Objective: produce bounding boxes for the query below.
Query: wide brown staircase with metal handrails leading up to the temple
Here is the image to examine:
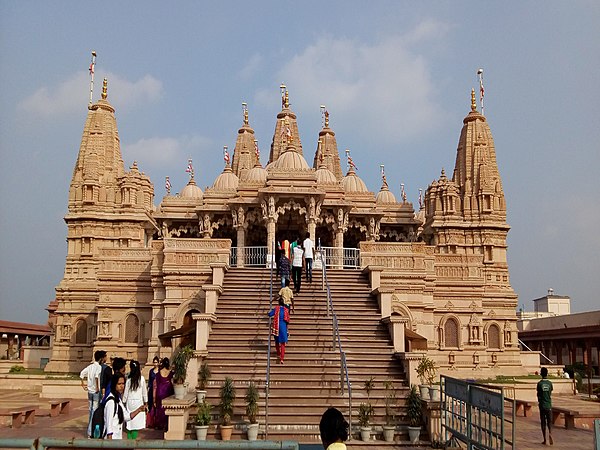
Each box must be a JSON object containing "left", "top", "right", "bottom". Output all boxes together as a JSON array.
[{"left": 199, "top": 268, "right": 407, "bottom": 446}]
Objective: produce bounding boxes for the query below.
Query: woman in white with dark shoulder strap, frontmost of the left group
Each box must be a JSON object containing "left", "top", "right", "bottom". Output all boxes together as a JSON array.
[{"left": 103, "top": 372, "right": 146, "bottom": 439}]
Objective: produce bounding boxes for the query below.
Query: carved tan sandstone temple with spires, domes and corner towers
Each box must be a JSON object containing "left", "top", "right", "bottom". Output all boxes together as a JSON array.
[{"left": 46, "top": 80, "right": 523, "bottom": 396}]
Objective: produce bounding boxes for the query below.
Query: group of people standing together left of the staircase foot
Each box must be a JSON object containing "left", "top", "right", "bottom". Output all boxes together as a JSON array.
[{"left": 80, "top": 350, "right": 173, "bottom": 439}]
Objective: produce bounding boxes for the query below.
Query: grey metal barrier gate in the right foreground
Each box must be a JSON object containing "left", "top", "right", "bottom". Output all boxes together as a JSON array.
[{"left": 441, "top": 375, "right": 516, "bottom": 450}]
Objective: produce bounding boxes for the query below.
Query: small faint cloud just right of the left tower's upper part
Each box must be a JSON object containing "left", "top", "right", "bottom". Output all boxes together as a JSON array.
[{"left": 121, "top": 136, "right": 211, "bottom": 168}]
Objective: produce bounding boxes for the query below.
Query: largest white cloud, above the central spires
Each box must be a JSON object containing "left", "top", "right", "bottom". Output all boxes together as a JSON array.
[{"left": 256, "top": 21, "right": 445, "bottom": 147}]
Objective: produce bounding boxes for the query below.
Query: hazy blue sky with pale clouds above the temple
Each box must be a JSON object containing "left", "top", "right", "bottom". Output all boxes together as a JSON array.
[{"left": 0, "top": 0, "right": 600, "bottom": 323}]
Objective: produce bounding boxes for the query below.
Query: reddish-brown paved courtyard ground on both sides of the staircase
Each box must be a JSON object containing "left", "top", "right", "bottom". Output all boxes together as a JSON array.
[{"left": 0, "top": 389, "right": 600, "bottom": 450}]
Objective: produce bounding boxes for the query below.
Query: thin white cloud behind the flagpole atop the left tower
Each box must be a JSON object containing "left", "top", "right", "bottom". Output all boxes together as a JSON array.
[{"left": 18, "top": 71, "right": 163, "bottom": 117}]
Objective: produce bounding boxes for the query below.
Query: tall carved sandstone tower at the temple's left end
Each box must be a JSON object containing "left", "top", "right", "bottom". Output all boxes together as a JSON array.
[{"left": 48, "top": 79, "right": 155, "bottom": 371}]
